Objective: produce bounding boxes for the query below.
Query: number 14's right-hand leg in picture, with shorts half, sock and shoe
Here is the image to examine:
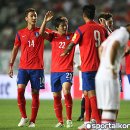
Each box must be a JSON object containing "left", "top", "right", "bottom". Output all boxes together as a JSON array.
[{"left": 29, "top": 70, "right": 44, "bottom": 127}]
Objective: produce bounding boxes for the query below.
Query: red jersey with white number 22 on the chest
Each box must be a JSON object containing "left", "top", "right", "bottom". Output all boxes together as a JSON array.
[{"left": 48, "top": 32, "right": 75, "bottom": 72}]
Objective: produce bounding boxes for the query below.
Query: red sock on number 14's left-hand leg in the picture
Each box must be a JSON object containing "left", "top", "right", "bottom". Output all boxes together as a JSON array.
[{"left": 17, "top": 88, "right": 27, "bottom": 118}]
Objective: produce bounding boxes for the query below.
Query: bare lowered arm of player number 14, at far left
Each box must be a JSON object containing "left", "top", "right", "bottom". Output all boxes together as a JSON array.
[{"left": 8, "top": 45, "right": 19, "bottom": 78}]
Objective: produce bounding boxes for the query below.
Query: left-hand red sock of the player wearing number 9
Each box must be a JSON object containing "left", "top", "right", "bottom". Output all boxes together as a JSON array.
[{"left": 85, "top": 96, "right": 91, "bottom": 121}]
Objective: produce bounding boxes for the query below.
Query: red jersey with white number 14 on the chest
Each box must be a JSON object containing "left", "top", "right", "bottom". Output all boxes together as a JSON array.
[{"left": 14, "top": 27, "right": 44, "bottom": 69}]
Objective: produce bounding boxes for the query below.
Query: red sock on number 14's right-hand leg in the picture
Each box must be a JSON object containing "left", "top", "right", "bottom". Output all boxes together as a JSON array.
[{"left": 30, "top": 94, "right": 39, "bottom": 123}]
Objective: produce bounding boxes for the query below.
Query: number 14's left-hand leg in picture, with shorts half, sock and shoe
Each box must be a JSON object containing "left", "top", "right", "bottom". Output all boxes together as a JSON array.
[{"left": 17, "top": 69, "right": 29, "bottom": 127}]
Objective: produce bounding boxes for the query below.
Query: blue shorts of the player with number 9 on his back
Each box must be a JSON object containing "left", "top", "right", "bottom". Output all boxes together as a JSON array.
[{"left": 82, "top": 71, "right": 97, "bottom": 91}]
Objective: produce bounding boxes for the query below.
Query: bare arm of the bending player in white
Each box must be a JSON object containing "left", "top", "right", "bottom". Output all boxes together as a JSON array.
[{"left": 110, "top": 41, "right": 120, "bottom": 78}]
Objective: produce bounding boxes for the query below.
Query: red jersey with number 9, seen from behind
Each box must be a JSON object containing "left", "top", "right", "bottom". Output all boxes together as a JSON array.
[{"left": 72, "top": 21, "right": 105, "bottom": 72}]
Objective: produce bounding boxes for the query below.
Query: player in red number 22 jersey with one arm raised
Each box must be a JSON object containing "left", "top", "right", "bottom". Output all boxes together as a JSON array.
[{"left": 40, "top": 11, "right": 75, "bottom": 128}]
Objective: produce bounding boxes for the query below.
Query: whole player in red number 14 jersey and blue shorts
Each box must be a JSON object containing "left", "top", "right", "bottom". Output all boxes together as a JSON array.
[{"left": 9, "top": 8, "right": 44, "bottom": 127}]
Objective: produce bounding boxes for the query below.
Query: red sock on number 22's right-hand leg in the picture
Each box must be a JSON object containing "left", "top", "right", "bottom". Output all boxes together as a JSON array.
[{"left": 64, "top": 93, "right": 73, "bottom": 120}]
